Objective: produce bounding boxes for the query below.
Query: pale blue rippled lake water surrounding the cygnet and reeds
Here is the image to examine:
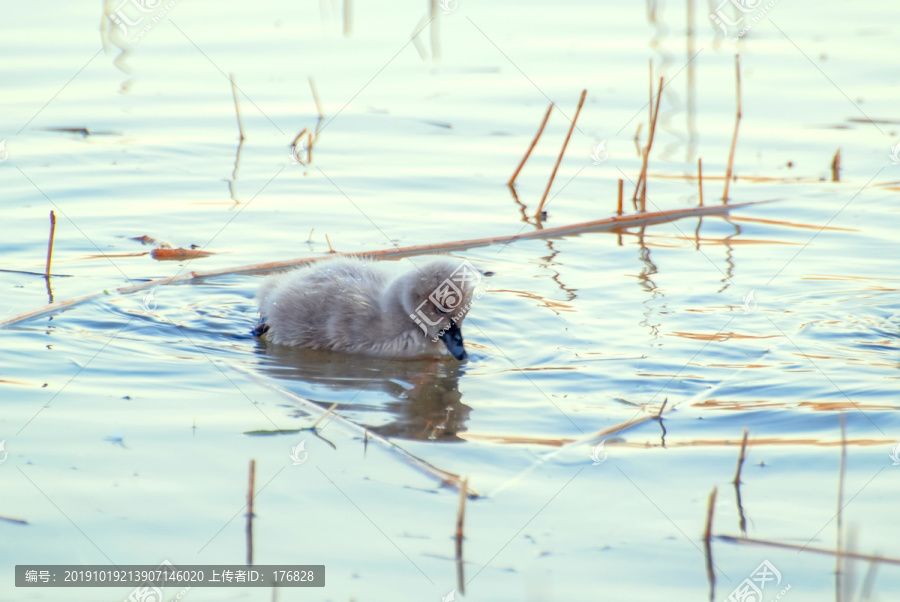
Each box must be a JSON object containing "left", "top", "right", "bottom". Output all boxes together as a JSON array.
[{"left": 0, "top": 0, "right": 900, "bottom": 602}]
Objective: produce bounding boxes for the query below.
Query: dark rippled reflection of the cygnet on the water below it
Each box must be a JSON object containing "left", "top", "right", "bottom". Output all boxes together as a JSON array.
[{"left": 250, "top": 343, "right": 472, "bottom": 441}]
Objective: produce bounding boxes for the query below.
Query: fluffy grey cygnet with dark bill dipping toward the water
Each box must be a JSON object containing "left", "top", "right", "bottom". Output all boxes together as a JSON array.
[{"left": 255, "top": 258, "right": 480, "bottom": 360}]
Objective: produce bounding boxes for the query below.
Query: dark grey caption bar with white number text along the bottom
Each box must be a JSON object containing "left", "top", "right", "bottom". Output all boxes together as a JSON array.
[{"left": 16, "top": 562, "right": 325, "bottom": 589}]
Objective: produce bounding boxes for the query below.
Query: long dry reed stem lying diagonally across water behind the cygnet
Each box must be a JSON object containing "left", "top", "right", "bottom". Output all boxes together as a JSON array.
[{"left": 0, "top": 200, "right": 772, "bottom": 326}]
